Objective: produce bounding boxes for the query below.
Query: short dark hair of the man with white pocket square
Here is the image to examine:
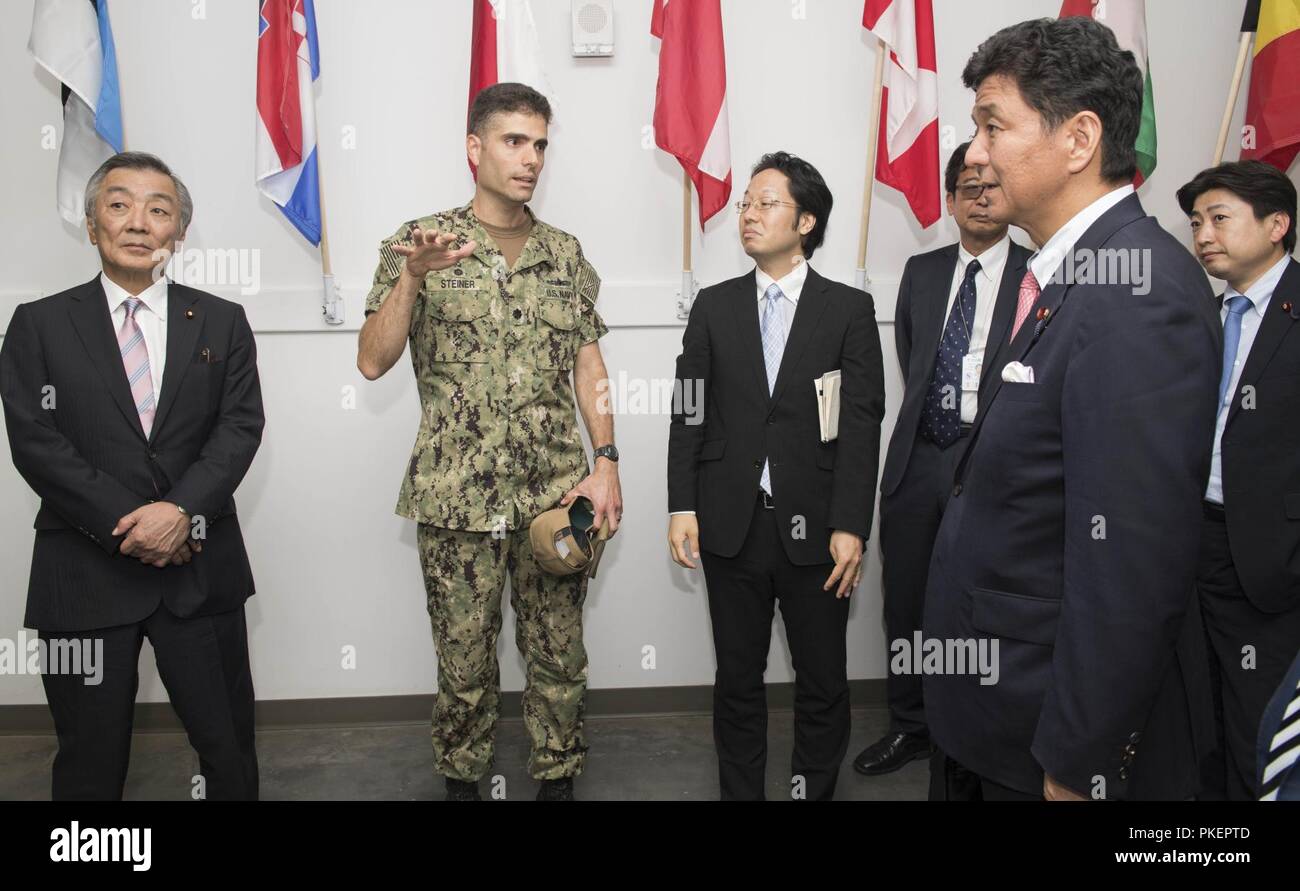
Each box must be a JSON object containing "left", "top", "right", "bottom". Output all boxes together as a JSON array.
[{"left": 962, "top": 16, "right": 1145, "bottom": 182}]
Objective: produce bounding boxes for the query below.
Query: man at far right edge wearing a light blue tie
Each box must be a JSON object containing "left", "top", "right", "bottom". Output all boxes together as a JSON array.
[{"left": 1178, "top": 161, "right": 1300, "bottom": 801}]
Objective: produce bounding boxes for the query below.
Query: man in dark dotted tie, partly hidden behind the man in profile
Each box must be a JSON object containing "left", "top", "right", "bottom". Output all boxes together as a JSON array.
[{"left": 853, "top": 142, "right": 1030, "bottom": 777}]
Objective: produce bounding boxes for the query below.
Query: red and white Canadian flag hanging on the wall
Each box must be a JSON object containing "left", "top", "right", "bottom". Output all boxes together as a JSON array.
[{"left": 862, "top": 0, "right": 940, "bottom": 229}]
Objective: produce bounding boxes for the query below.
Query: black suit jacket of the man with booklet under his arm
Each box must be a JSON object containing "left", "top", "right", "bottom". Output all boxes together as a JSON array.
[{"left": 668, "top": 267, "right": 885, "bottom": 566}]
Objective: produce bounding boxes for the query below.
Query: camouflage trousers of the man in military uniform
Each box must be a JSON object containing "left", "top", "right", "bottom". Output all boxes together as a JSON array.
[{"left": 416, "top": 523, "right": 588, "bottom": 780}]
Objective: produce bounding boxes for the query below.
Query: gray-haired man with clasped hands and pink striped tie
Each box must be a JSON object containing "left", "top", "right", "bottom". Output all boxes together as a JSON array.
[{"left": 0, "top": 152, "right": 263, "bottom": 800}]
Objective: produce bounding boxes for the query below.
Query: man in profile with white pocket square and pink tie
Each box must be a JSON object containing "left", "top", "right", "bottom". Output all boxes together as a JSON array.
[{"left": 923, "top": 18, "right": 1222, "bottom": 800}]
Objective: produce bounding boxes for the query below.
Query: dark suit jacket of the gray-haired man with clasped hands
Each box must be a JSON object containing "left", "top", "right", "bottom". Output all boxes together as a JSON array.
[{"left": 0, "top": 276, "right": 263, "bottom": 631}]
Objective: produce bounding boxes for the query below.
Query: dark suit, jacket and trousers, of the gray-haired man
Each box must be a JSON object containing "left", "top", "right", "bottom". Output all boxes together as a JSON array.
[{"left": 0, "top": 276, "right": 263, "bottom": 799}]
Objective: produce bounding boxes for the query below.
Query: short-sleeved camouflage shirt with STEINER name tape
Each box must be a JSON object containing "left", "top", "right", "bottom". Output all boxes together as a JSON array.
[{"left": 365, "top": 204, "right": 608, "bottom": 532}]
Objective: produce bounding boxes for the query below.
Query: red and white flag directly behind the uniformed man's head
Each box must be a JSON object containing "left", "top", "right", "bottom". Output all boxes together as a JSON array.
[{"left": 465, "top": 0, "right": 555, "bottom": 170}]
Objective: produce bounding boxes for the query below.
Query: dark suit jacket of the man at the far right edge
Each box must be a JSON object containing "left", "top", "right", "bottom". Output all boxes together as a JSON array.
[{"left": 1219, "top": 259, "right": 1300, "bottom": 613}]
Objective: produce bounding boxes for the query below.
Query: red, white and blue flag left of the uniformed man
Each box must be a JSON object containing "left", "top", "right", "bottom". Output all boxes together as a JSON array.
[{"left": 256, "top": 0, "right": 321, "bottom": 245}]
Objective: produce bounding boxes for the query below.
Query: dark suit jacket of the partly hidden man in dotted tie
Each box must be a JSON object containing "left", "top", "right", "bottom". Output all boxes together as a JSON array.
[{"left": 880, "top": 241, "right": 1031, "bottom": 497}]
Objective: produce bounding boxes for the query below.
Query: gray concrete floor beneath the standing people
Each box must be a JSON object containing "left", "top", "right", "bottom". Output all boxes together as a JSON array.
[{"left": 0, "top": 708, "right": 930, "bottom": 801}]
